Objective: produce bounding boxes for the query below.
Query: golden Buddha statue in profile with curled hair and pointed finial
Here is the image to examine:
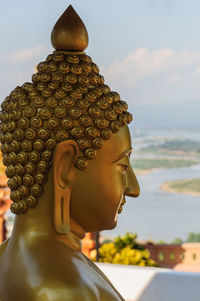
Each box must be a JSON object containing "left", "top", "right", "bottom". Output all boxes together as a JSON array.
[{"left": 0, "top": 6, "right": 139, "bottom": 301}]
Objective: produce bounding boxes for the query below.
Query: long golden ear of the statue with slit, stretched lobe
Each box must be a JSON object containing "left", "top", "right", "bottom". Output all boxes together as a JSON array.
[{"left": 53, "top": 140, "right": 78, "bottom": 233}]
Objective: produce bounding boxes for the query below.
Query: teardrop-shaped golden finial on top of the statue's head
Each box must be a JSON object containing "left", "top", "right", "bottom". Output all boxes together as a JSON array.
[{"left": 51, "top": 5, "right": 88, "bottom": 51}]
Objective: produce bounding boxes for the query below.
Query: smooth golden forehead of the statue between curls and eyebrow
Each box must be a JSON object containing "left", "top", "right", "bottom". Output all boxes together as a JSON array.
[{"left": 97, "top": 125, "right": 131, "bottom": 162}]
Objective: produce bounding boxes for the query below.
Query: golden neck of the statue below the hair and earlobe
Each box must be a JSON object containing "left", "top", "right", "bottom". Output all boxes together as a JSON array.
[{"left": 11, "top": 171, "right": 85, "bottom": 250}]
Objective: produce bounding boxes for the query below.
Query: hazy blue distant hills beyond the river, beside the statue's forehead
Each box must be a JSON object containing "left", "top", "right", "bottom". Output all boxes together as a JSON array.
[{"left": 131, "top": 100, "right": 200, "bottom": 129}]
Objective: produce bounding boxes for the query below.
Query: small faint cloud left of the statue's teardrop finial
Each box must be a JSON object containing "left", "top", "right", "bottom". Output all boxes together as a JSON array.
[{"left": 9, "top": 46, "right": 46, "bottom": 63}]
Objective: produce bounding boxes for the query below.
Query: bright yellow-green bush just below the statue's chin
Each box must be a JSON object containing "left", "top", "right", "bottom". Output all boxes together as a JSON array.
[{"left": 99, "top": 232, "right": 158, "bottom": 266}]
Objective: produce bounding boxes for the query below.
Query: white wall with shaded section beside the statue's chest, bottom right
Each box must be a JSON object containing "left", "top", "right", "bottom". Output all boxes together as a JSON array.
[{"left": 97, "top": 263, "right": 200, "bottom": 301}]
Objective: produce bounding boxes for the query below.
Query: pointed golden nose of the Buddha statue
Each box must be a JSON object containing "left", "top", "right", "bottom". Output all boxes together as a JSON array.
[{"left": 124, "top": 166, "right": 140, "bottom": 198}]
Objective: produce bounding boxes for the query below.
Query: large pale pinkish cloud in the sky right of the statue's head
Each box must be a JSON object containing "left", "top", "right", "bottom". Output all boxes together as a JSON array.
[{"left": 104, "top": 48, "right": 200, "bottom": 87}]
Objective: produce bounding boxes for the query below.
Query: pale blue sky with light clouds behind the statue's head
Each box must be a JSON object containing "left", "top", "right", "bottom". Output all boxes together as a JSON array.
[{"left": 0, "top": 0, "right": 200, "bottom": 109}]
